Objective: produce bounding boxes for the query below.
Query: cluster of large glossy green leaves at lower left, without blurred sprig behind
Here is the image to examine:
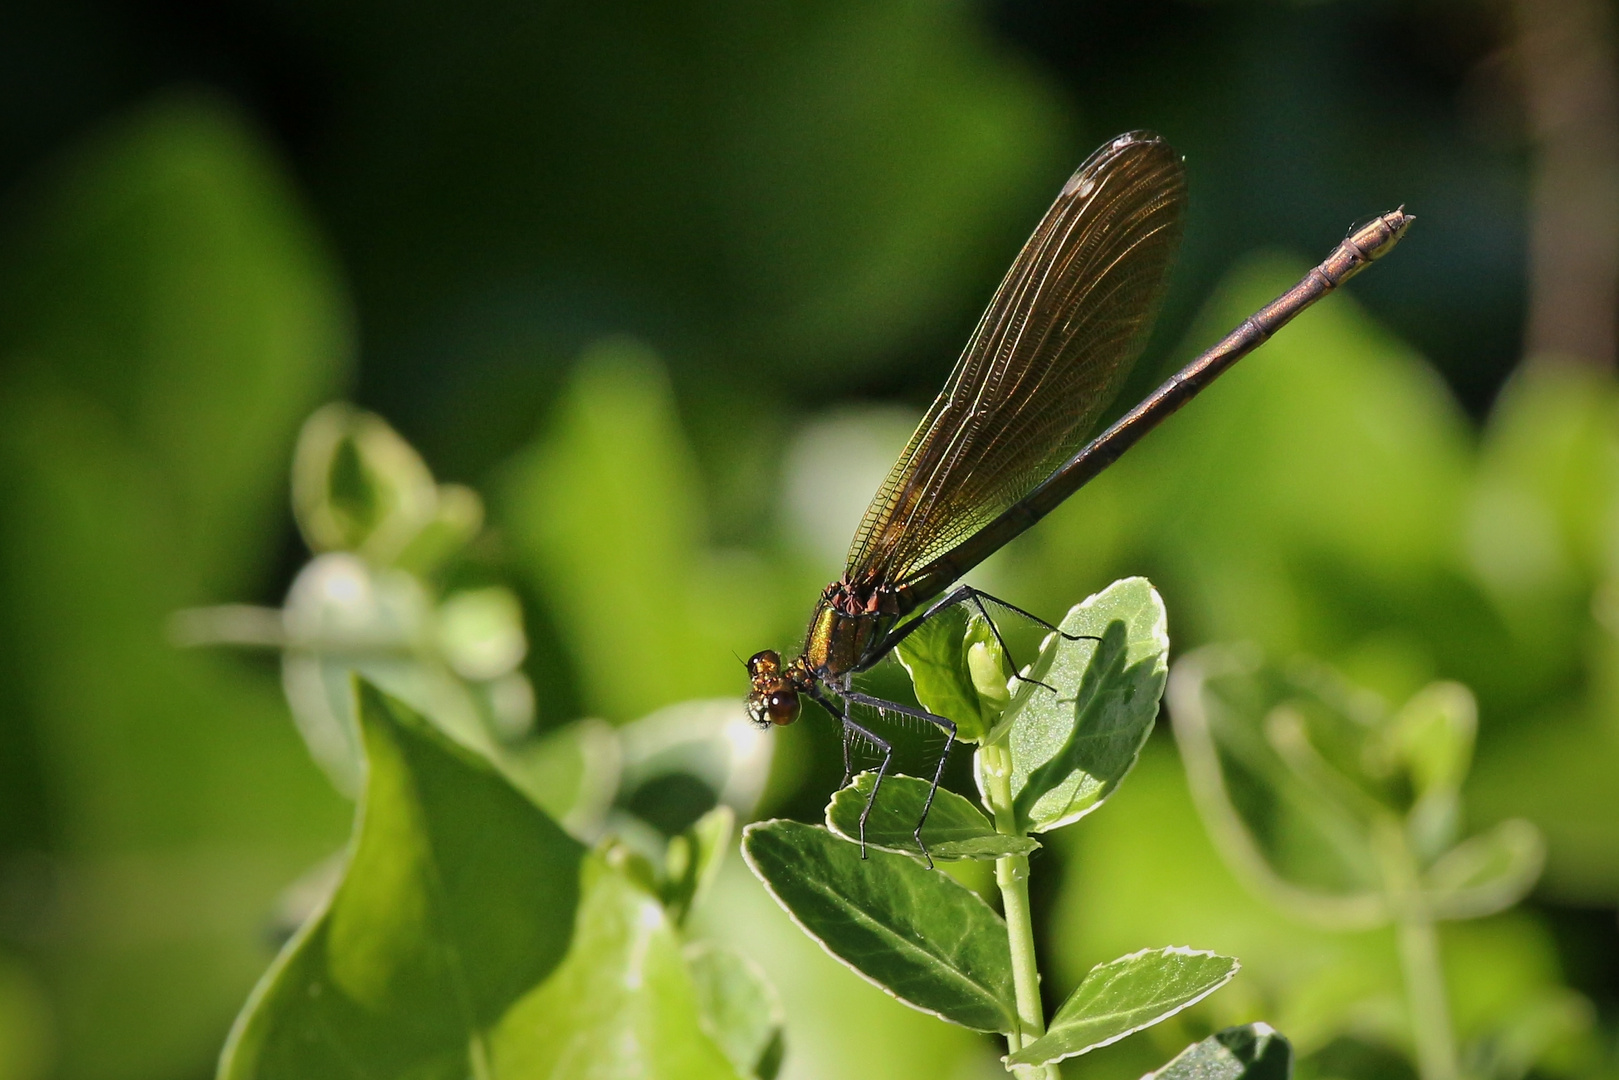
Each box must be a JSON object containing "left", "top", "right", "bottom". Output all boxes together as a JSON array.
[{"left": 220, "top": 682, "right": 782, "bottom": 1080}]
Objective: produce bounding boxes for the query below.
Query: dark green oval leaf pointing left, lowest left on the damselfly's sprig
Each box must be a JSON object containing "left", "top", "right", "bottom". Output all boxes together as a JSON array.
[{"left": 742, "top": 821, "right": 1015, "bottom": 1031}]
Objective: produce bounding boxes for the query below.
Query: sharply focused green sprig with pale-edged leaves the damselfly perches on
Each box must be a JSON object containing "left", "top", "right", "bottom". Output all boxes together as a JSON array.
[{"left": 743, "top": 578, "right": 1275, "bottom": 1077}]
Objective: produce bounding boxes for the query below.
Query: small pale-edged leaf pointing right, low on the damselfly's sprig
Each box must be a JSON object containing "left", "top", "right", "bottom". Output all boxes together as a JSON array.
[{"left": 1007, "top": 949, "right": 1242, "bottom": 1065}]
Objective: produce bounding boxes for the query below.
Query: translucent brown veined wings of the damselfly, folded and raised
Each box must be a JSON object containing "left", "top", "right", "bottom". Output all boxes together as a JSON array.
[{"left": 845, "top": 131, "right": 1187, "bottom": 595}]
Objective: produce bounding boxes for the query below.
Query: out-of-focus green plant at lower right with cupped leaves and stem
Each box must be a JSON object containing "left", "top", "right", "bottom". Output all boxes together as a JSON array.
[{"left": 1169, "top": 646, "right": 1590, "bottom": 1080}]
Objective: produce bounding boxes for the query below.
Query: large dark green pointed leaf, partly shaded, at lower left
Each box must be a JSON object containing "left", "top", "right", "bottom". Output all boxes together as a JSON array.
[{"left": 219, "top": 683, "right": 586, "bottom": 1080}]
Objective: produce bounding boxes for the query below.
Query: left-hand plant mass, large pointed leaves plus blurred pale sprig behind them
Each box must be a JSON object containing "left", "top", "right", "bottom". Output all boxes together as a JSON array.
[{"left": 199, "top": 405, "right": 799, "bottom": 1080}]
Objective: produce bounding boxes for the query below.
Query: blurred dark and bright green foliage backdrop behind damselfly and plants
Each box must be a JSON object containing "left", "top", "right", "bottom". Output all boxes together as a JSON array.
[{"left": 0, "top": 0, "right": 1619, "bottom": 1080}]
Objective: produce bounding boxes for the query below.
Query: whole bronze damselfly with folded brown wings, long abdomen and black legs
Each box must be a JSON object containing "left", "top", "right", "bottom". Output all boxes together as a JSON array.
[{"left": 748, "top": 131, "right": 1412, "bottom": 853}]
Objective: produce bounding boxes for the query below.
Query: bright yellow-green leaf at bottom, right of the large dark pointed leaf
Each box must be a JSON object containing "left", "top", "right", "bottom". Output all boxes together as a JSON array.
[{"left": 492, "top": 858, "right": 740, "bottom": 1080}]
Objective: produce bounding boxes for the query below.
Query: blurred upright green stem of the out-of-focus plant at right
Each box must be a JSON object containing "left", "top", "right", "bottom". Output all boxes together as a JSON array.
[{"left": 1378, "top": 818, "right": 1459, "bottom": 1080}]
